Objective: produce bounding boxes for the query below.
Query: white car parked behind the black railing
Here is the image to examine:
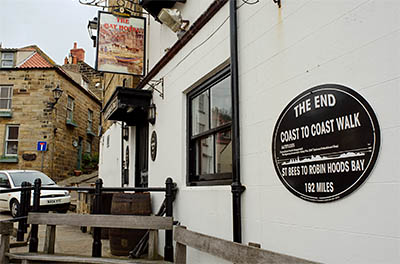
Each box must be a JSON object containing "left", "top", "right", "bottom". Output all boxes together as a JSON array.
[{"left": 0, "top": 170, "right": 71, "bottom": 217}]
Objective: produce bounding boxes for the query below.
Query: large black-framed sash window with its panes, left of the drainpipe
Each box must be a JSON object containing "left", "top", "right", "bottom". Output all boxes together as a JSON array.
[{"left": 188, "top": 68, "right": 232, "bottom": 185}]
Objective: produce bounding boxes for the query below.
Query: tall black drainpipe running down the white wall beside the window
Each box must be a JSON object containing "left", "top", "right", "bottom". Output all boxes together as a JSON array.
[{"left": 229, "top": 0, "right": 246, "bottom": 243}]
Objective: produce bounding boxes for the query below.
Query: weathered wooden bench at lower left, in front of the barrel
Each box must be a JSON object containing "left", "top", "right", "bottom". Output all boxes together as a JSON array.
[{"left": 0, "top": 213, "right": 173, "bottom": 264}]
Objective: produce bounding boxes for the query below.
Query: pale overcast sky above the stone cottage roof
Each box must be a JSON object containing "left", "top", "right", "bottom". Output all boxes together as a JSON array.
[{"left": 0, "top": 0, "right": 100, "bottom": 67}]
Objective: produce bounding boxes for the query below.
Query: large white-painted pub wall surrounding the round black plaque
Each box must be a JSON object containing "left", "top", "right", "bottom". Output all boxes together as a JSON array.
[{"left": 138, "top": 0, "right": 400, "bottom": 263}]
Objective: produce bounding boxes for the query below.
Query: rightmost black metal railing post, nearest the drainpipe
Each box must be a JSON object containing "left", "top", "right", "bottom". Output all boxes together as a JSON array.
[{"left": 164, "top": 178, "right": 174, "bottom": 262}]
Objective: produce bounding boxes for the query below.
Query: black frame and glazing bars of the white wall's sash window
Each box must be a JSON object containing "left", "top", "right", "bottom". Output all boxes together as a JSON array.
[{"left": 186, "top": 66, "right": 234, "bottom": 186}]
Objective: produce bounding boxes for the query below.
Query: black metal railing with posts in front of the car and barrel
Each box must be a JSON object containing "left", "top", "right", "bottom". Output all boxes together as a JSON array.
[{"left": 0, "top": 178, "right": 177, "bottom": 261}]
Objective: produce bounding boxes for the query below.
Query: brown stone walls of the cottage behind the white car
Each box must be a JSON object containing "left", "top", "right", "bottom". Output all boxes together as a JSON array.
[{"left": 0, "top": 68, "right": 101, "bottom": 181}]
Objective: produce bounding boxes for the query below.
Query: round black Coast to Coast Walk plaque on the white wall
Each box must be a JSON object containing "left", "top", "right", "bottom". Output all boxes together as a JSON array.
[{"left": 272, "top": 84, "right": 380, "bottom": 202}]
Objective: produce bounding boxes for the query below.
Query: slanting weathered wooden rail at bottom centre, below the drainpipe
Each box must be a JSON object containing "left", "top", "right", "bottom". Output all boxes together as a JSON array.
[{"left": 174, "top": 226, "right": 316, "bottom": 264}]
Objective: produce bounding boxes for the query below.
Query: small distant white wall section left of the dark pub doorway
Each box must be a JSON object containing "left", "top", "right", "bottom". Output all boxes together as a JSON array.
[{"left": 99, "top": 122, "right": 121, "bottom": 187}]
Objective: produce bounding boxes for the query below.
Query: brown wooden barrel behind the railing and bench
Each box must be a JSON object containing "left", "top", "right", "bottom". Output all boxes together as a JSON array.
[{"left": 109, "top": 193, "right": 151, "bottom": 256}]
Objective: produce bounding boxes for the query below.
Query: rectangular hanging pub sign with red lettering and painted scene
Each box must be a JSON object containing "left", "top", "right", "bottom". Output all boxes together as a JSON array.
[{"left": 96, "top": 11, "right": 146, "bottom": 76}]
